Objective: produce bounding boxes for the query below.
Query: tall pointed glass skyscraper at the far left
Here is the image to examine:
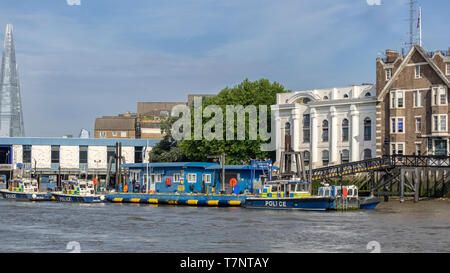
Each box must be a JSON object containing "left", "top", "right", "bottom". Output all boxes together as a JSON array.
[{"left": 0, "top": 24, "right": 25, "bottom": 137}]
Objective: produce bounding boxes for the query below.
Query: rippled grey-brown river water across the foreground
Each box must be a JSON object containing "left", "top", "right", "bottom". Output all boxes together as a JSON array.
[{"left": 0, "top": 199, "right": 450, "bottom": 253}]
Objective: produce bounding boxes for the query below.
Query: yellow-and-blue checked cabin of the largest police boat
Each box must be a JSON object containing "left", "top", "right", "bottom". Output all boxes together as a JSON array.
[{"left": 262, "top": 180, "right": 311, "bottom": 198}]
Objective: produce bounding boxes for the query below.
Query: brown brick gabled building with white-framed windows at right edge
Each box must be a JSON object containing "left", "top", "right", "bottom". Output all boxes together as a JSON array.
[{"left": 376, "top": 45, "right": 450, "bottom": 156}]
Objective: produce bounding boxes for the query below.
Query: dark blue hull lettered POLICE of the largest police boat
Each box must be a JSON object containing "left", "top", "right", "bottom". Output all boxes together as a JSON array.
[{"left": 244, "top": 197, "right": 333, "bottom": 211}]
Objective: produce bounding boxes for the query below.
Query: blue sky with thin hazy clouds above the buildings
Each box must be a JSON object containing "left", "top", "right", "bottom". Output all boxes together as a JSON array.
[{"left": 0, "top": 0, "right": 450, "bottom": 137}]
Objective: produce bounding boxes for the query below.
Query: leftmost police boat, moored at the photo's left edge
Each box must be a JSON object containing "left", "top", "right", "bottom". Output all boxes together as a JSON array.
[{"left": 0, "top": 178, "right": 52, "bottom": 201}]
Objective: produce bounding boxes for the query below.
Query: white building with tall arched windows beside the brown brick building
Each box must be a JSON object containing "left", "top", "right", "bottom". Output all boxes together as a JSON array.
[{"left": 271, "top": 84, "right": 376, "bottom": 168}]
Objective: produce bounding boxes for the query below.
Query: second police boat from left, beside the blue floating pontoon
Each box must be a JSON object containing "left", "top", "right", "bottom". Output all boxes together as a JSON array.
[{"left": 52, "top": 180, "right": 106, "bottom": 203}]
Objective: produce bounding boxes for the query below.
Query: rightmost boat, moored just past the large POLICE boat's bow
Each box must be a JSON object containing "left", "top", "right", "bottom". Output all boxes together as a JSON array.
[{"left": 318, "top": 184, "right": 380, "bottom": 210}]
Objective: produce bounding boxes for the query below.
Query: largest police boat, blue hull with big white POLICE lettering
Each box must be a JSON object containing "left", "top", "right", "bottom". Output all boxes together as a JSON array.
[{"left": 244, "top": 179, "right": 333, "bottom": 211}]
